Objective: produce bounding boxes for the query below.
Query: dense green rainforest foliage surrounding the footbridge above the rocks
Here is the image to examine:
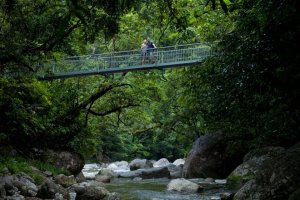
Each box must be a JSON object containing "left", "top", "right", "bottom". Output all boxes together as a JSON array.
[{"left": 0, "top": 0, "right": 300, "bottom": 160}]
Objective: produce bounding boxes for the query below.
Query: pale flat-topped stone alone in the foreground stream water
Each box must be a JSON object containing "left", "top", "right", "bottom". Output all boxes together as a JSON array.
[{"left": 167, "top": 178, "right": 202, "bottom": 194}]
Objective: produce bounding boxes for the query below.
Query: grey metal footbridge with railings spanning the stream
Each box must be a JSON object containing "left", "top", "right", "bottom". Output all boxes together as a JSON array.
[{"left": 37, "top": 43, "right": 211, "bottom": 80}]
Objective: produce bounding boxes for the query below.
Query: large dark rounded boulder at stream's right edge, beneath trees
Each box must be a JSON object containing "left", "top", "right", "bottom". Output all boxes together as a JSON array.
[{"left": 183, "top": 132, "right": 243, "bottom": 178}]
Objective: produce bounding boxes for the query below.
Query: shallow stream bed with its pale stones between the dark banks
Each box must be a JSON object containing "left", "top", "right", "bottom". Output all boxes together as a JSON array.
[{"left": 83, "top": 159, "right": 232, "bottom": 200}]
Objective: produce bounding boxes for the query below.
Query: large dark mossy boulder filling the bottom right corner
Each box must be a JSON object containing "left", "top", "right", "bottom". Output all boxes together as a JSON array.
[{"left": 231, "top": 143, "right": 300, "bottom": 200}]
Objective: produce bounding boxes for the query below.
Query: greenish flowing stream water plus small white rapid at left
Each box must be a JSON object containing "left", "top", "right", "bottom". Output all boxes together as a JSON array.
[{"left": 84, "top": 164, "right": 231, "bottom": 200}]
